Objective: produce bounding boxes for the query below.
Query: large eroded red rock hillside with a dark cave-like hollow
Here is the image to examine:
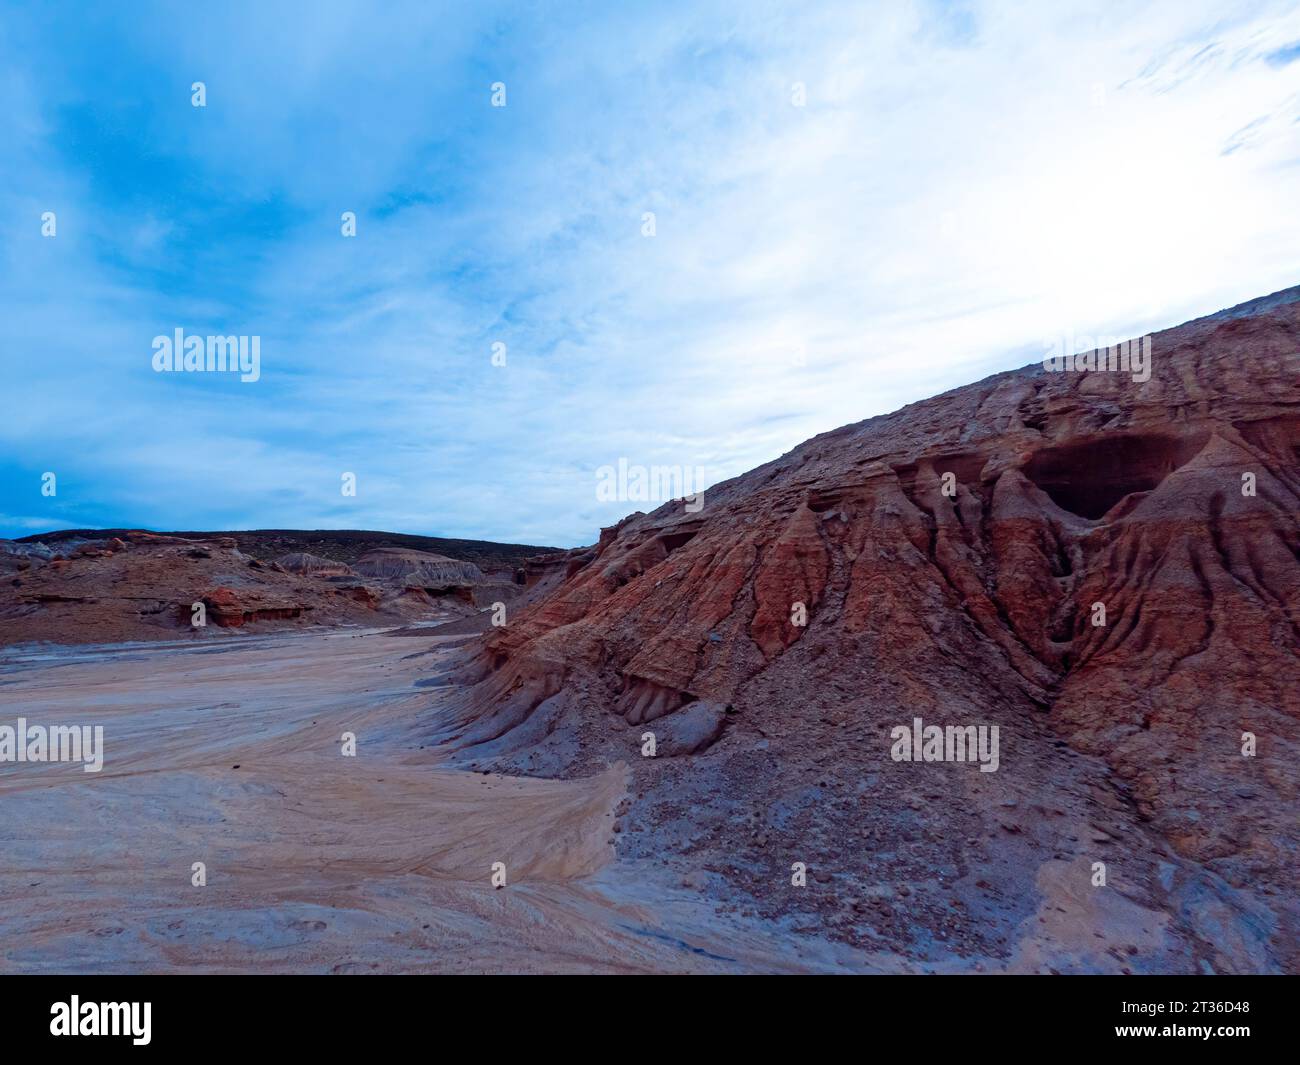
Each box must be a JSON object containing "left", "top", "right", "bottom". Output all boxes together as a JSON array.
[{"left": 445, "top": 289, "right": 1300, "bottom": 969}]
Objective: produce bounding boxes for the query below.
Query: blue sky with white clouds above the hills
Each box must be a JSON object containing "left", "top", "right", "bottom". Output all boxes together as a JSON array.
[{"left": 0, "top": 0, "right": 1300, "bottom": 546}]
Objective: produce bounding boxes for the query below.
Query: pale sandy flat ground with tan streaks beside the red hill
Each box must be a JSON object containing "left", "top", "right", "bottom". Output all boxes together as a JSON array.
[{"left": 0, "top": 631, "right": 878, "bottom": 973}]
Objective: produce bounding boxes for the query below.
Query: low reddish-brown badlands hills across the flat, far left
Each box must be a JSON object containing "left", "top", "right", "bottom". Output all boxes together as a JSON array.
[{"left": 0, "top": 529, "right": 559, "bottom": 645}]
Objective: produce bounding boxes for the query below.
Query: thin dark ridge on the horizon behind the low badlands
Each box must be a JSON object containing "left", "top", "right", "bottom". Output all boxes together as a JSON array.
[{"left": 20, "top": 529, "right": 560, "bottom": 573}]
